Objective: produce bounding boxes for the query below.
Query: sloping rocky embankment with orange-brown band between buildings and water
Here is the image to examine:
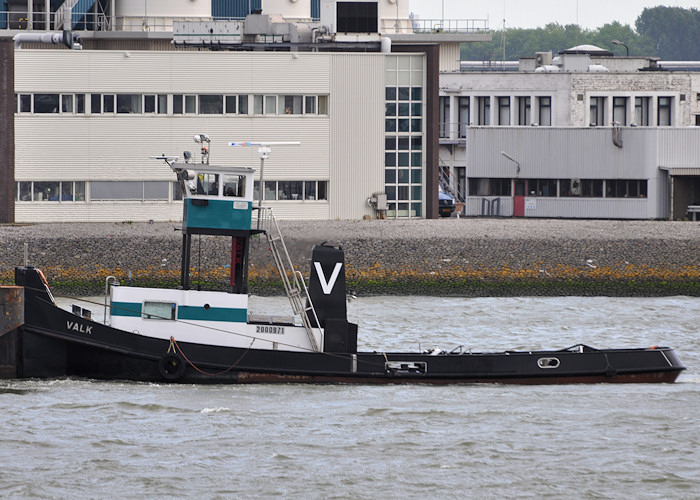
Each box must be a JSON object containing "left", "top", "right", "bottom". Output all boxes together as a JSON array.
[{"left": 0, "top": 218, "right": 700, "bottom": 296}]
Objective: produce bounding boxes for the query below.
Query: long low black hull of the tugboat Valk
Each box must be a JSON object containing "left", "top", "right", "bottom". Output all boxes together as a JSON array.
[{"left": 0, "top": 297, "right": 684, "bottom": 384}]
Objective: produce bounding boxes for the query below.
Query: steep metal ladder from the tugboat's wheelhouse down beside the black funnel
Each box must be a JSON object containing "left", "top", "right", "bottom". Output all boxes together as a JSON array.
[{"left": 254, "top": 207, "right": 321, "bottom": 352}]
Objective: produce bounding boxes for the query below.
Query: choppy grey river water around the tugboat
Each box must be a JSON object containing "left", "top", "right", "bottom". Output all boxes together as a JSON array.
[{"left": 0, "top": 297, "right": 700, "bottom": 499}]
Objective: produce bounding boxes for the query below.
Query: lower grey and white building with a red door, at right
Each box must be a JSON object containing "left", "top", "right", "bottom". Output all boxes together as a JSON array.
[{"left": 439, "top": 46, "right": 700, "bottom": 219}]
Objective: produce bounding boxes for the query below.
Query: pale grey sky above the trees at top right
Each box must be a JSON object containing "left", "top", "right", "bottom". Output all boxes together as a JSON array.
[{"left": 408, "top": 0, "right": 700, "bottom": 29}]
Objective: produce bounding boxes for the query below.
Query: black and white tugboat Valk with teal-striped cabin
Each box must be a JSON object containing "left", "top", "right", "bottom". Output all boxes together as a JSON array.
[{"left": 0, "top": 140, "right": 685, "bottom": 384}]
